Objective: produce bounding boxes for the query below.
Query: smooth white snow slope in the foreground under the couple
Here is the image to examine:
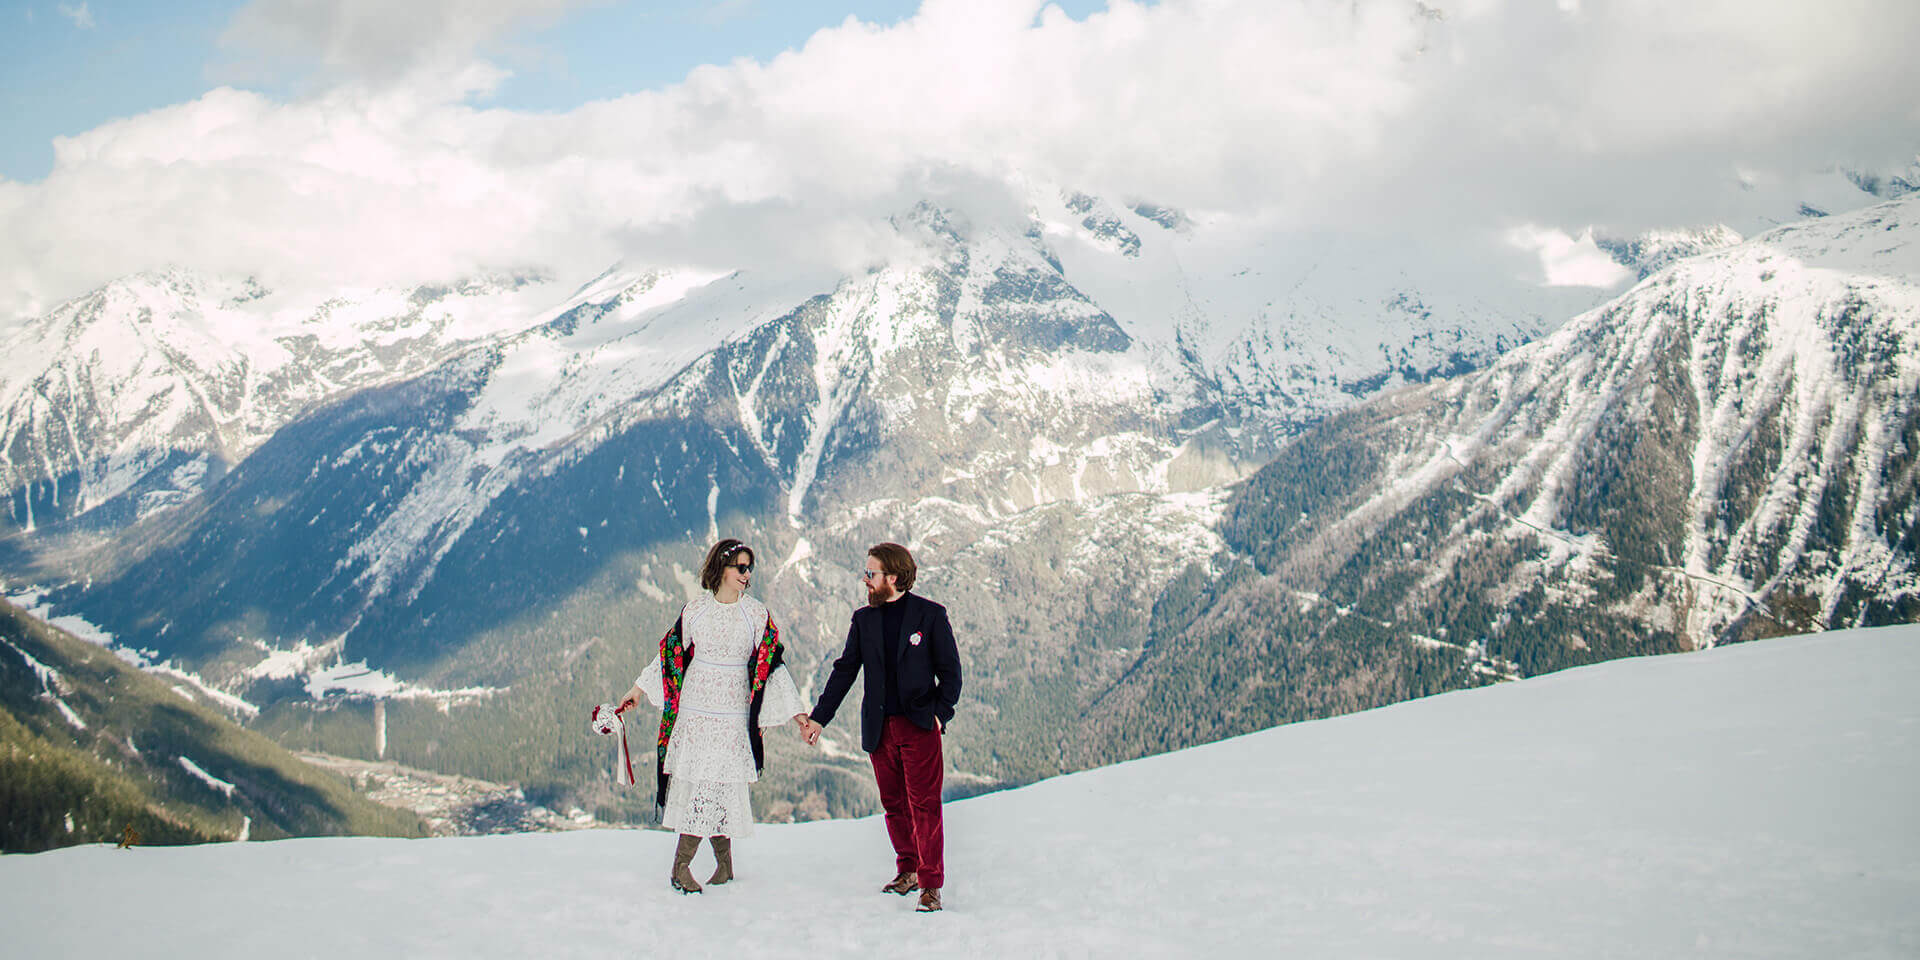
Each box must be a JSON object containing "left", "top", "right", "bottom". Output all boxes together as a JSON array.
[{"left": 0, "top": 626, "right": 1920, "bottom": 958}]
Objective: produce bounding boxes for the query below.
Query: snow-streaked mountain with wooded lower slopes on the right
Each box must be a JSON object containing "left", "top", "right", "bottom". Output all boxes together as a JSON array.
[{"left": 1064, "top": 196, "right": 1920, "bottom": 756}]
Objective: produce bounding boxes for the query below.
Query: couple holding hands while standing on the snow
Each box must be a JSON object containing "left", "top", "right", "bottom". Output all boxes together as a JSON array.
[{"left": 620, "top": 540, "right": 960, "bottom": 912}]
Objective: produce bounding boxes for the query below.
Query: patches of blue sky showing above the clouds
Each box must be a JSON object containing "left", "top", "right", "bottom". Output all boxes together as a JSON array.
[{"left": 0, "top": 0, "right": 1106, "bottom": 182}]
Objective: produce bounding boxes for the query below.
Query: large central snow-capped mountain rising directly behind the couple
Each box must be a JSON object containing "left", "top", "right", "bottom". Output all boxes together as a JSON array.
[{"left": 15, "top": 167, "right": 1910, "bottom": 812}]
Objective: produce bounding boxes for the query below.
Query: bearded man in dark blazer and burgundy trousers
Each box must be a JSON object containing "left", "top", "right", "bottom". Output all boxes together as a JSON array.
[{"left": 806, "top": 543, "right": 960, "bottom": 912}]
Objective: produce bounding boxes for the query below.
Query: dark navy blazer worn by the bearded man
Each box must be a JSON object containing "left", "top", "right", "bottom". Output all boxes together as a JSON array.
[{"left": 812, "top": 593, "right": 960, "bottom": 753}]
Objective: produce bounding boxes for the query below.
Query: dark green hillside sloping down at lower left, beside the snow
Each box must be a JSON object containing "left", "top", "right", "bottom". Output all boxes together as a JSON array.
[{"left": 0, "top": 603, "right": 424, "bottom": 852}]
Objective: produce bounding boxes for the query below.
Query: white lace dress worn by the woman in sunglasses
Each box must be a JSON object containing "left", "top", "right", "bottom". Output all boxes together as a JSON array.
[{"left": 636, "top": 593, "right": 806, "bottom": 837}]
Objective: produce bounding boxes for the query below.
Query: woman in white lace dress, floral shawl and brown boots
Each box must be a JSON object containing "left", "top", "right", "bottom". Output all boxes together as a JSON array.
[{"left": 620, "top": 538, "right": 806, "bottom": 893}]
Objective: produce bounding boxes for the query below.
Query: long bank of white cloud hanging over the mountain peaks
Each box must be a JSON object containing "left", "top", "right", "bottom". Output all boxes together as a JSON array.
[{"left": 0, "top": 0, "right": 1920, "bottom": 317}]
